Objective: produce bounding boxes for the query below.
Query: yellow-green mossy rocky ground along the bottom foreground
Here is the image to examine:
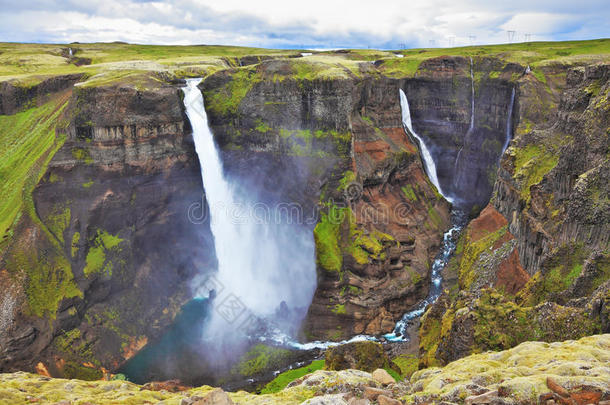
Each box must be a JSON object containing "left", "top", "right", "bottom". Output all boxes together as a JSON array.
[{"left": 0, "top": 334, "right": 610, "bottom": 405}]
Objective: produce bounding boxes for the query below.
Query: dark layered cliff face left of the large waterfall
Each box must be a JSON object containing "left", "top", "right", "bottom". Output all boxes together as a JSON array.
[{"left": 0, "top": 82, "right": 215, "bottom": 377}]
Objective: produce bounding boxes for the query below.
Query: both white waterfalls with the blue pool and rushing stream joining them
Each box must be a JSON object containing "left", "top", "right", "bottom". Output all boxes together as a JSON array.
[{"left": 123, "top": 79, "right": 480, "bottom": 387}]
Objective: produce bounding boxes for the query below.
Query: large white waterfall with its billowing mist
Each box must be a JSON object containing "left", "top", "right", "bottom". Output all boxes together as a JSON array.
[{"left": 183, "top": 79, "right": 316, "bottom": 336}]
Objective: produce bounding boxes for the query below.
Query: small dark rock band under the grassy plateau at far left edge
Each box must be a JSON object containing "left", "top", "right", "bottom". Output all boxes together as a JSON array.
[{"left": 0, "top": 73, "right": 84, "bottom": 115}]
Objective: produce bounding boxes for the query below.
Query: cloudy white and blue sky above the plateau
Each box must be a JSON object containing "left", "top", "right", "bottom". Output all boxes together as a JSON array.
[{"left": 0, "top": 0, "right": 610, "bottom": 48}]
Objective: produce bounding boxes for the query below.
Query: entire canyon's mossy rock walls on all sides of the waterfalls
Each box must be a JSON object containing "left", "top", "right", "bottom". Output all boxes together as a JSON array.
[{"left": 0, "top": 40, "right": 610, "bottom": 394}]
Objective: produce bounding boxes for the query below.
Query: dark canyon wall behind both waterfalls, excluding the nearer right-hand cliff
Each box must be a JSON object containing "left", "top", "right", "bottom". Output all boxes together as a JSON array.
[{"left": 0, "top": 57, "right": 523, "bottom": 377}]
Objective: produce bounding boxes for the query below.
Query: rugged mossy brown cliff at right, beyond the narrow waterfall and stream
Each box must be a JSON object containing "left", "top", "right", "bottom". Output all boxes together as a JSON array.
[{"left": 420, "top": 64, "right": 610, "bottom": 365}]
